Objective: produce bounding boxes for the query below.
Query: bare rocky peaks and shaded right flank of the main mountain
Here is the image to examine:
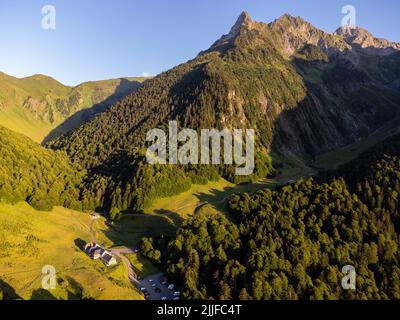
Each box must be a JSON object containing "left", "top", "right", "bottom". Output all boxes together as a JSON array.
[{"left": 212, "top": 15, "right": 400, "bottom": 157}]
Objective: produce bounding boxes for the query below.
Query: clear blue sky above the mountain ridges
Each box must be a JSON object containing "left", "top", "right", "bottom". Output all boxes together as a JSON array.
[{"left": 0, "top": 0, "right": 400, "bottom": 85}]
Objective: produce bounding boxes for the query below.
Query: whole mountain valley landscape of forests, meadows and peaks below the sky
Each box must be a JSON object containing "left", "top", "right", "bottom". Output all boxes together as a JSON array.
[{"left": 0, "top": 12, "right": 400, "bottom": 300}]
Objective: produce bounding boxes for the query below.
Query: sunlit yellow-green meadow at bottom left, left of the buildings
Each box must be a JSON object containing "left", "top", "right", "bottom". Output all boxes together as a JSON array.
[{"left": 0, "top": 203, "right": 142, "bottom": 299}]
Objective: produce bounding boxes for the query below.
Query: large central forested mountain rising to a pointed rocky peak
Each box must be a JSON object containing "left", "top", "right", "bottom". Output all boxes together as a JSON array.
[{"left": 42, "top": 13, "right": 400, "bottom": 211}]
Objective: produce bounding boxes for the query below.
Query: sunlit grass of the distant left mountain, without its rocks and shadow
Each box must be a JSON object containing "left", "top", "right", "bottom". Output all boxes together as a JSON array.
[{"left": 0, "top": 73, "right": 146, "bottom": 143}]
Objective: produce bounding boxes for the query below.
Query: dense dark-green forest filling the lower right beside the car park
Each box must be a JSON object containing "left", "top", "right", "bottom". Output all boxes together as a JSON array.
[{"left": 142, "top": 136, "right": 400, "bottom": 300}]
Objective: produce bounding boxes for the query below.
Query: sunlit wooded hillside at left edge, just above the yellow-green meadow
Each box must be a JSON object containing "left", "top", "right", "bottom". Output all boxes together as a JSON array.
[{"left": 0, "top": 126, "right": 84, "bottom": 210}]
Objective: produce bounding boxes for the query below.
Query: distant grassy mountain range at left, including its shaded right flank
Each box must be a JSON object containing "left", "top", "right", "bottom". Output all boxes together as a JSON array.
[{"left": 0, "top": 73, "right": 145, "bottom": 142}]
